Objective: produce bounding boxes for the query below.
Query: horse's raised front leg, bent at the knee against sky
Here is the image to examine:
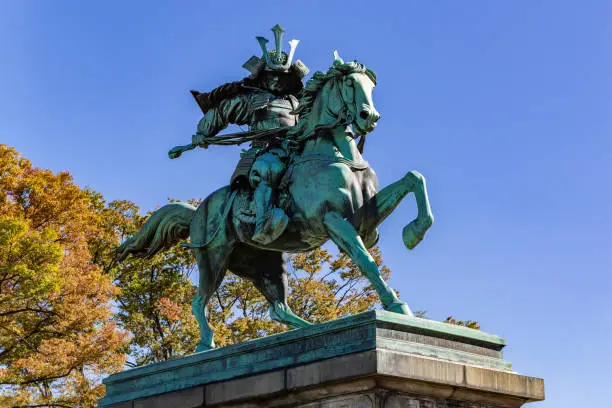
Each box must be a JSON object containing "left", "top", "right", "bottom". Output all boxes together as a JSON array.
[{"left": 355, "top": 170, "right": 434, "bottom": 249}]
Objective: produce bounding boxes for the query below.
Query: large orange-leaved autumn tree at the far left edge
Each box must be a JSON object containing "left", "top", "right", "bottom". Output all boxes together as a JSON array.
[{"left": 0, "top": 145, "right": 128, "bottom": 407}]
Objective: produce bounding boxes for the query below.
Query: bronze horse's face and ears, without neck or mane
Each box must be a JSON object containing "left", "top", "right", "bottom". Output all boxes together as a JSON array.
[{"left": 328, "top": 52, "right": 380, "bottom": 134}]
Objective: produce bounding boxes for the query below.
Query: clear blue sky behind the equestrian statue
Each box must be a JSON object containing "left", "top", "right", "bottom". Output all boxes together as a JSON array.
[{"left": 0, "top": 0, "right": 612, "bottom": 408}]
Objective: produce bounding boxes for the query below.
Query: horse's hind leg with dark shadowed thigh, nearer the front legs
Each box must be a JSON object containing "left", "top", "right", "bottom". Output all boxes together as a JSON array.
[{"left": 229, "top": 247, "right": 312, "bottom": 329}]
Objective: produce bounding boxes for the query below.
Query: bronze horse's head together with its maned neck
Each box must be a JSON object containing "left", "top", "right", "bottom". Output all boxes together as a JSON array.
[{"left": 290, "top": 52, "right": 380, "bottom": 139}]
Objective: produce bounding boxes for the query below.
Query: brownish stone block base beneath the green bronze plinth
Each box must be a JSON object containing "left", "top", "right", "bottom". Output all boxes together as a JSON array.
[{"left": 107, "top": 351, "right": 544, "bottom": 408}]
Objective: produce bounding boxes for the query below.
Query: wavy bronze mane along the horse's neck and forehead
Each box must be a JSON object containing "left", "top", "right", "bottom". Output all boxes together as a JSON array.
[{"left": 288, "top": 61, "right": 376, "bottom": 136}]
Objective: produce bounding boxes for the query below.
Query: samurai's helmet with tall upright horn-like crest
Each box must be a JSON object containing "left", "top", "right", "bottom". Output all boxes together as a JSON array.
[{"left": 242, "top": 24, "right": 310, "bottom": 79}]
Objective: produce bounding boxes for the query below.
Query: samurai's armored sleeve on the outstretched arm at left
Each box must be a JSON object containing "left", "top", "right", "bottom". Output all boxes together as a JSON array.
[{"left": 198, "top": 95, "right": 250, "bottom": 137}]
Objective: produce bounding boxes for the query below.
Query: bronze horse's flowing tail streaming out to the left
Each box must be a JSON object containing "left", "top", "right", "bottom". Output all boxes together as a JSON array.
[{"left": 115, "top": 203, "right": 196, "bottom": 261}]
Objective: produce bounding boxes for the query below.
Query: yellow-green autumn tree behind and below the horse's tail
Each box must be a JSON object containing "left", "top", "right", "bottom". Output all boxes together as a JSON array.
[{"left": 91, "top": 198, "right": 199, "bottom": 366}]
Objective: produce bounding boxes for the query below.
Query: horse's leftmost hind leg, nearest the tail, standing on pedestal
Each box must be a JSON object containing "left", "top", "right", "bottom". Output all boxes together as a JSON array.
[{"left": 191, "top": 245, "right": 231, "bottom": 353}]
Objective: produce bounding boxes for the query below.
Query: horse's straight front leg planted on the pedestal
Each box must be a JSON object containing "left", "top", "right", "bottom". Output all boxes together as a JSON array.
[{"left": 324, "top": 212, "right": 412, "bottom": 315}]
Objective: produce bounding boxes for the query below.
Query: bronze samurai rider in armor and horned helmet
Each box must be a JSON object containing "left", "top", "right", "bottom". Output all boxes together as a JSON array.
[{"left": 191, "top": 24, "right": 309, "bottom": 244}]
